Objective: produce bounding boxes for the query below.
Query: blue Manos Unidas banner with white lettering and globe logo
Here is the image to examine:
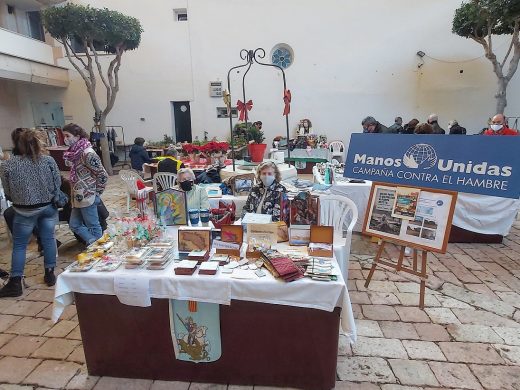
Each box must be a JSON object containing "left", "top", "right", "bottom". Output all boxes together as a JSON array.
[{"left": 343, "top": 134, "right": 520, "bottom": 199}]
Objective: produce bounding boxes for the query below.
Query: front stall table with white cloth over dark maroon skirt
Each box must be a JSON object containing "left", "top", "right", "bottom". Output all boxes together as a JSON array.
[{"left": 53, "top": 242, "right": 356, "bottom": 389}]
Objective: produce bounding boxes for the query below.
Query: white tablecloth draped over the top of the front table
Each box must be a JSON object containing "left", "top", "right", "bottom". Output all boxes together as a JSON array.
[{"left": 52, "top": 244, "right": 356, "bottom": 342}]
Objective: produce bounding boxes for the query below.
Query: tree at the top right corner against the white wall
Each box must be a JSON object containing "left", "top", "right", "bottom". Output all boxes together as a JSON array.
[{"left": 452, "top": 0, "right": 520, "bottom": 114}]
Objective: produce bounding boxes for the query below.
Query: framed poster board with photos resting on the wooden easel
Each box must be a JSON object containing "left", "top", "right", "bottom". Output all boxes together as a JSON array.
[{"left": 363, "top": 182, "right": 457, "bottom": 253}]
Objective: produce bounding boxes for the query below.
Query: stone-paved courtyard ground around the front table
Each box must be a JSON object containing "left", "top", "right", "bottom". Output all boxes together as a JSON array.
[{"left": 0, "top": 178, "right": 520, "bottom": 390}]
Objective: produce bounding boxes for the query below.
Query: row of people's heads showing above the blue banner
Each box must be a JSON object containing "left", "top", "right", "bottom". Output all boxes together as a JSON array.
[{"left": 361, "top": 114, "right": 519, "bottom": 135}]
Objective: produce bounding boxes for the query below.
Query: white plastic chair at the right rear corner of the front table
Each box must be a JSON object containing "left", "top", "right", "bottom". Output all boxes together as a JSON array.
[{"left": 320, "top": 195, "right": 358, "bottom": 283}]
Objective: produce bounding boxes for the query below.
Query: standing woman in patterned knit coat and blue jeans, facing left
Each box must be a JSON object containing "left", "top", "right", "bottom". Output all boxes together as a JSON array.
[{"left": 63, "top": 123, "right": 108, "bottom": 246}]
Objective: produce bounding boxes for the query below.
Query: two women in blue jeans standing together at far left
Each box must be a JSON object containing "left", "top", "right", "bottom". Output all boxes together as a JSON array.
[{"left": 0, "top": 124, "right": 108, "bottom": 298}]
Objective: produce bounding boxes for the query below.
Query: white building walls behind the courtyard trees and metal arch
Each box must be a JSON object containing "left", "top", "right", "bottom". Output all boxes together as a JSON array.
[{"left": 0, "top": 0, "right": 520, "bottom": 146}]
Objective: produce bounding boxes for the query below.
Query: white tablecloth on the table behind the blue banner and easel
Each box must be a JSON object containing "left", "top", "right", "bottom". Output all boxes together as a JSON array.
[{"left": 330, "top": 181, "right": 520, "bottom": 236}]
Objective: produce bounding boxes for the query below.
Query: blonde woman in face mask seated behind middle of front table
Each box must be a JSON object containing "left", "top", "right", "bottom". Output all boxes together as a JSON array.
[{"left": 242, "top": 161, "right": 287, "bottom": 222}]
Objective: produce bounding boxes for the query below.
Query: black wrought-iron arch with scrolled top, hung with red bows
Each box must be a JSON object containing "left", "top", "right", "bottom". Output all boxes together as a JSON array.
[{"left": 227, "top": 47, "right": 291, "bottom": 171}]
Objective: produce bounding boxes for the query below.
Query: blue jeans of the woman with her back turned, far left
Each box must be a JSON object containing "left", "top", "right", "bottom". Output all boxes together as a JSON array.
[{"left": 11, "top": 205, "right": 58, "bottom": 276}]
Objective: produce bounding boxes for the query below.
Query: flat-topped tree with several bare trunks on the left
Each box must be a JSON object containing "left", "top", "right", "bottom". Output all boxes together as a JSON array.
[{"left": 42, "top": 4, "right": 143, "bottom": 174}]
